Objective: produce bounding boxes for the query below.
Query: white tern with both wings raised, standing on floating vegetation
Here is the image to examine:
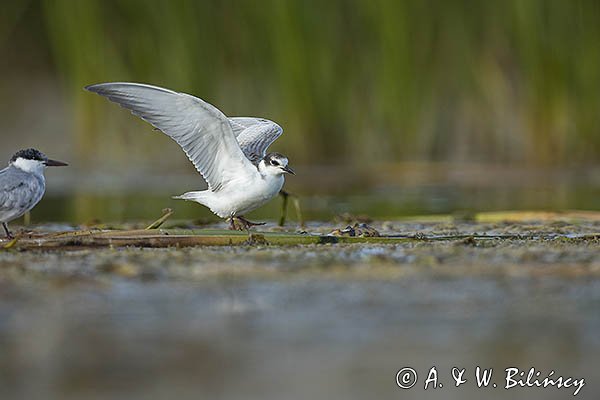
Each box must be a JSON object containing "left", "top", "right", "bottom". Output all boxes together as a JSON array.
[{"left": 85, "top": 82, "right": 294, "bottom": 230}]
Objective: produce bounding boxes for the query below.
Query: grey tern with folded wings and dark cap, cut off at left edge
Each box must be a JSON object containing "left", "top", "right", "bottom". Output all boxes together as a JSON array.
[{"left": 0, "top": 149, "right": 68, "bottom": 239}]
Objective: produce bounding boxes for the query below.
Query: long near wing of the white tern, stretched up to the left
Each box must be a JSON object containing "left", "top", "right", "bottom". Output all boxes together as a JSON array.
[{"left": 86, "top": 82, "right": 258, "bottom": 191}]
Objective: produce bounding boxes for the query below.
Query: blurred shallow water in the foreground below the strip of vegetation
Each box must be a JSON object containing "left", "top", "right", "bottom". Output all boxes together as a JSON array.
[{"left": 0, "top": 221, "right": 600, "bottom": 399}]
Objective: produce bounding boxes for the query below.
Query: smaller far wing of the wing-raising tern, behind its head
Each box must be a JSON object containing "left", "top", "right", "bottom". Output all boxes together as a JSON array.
[{"left": 229, "top": 117, "right": 283, "bottom": 164}]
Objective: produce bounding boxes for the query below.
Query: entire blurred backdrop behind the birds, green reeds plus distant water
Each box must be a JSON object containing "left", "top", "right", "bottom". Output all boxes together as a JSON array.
[{"left": 0, "top": 0, "right": 600, "bottom": 221}]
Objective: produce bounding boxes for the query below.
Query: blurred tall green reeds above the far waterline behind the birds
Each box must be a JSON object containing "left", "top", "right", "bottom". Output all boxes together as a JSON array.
[{"left": 0, "top": 0, "right": 600, "bottom": 166}]
